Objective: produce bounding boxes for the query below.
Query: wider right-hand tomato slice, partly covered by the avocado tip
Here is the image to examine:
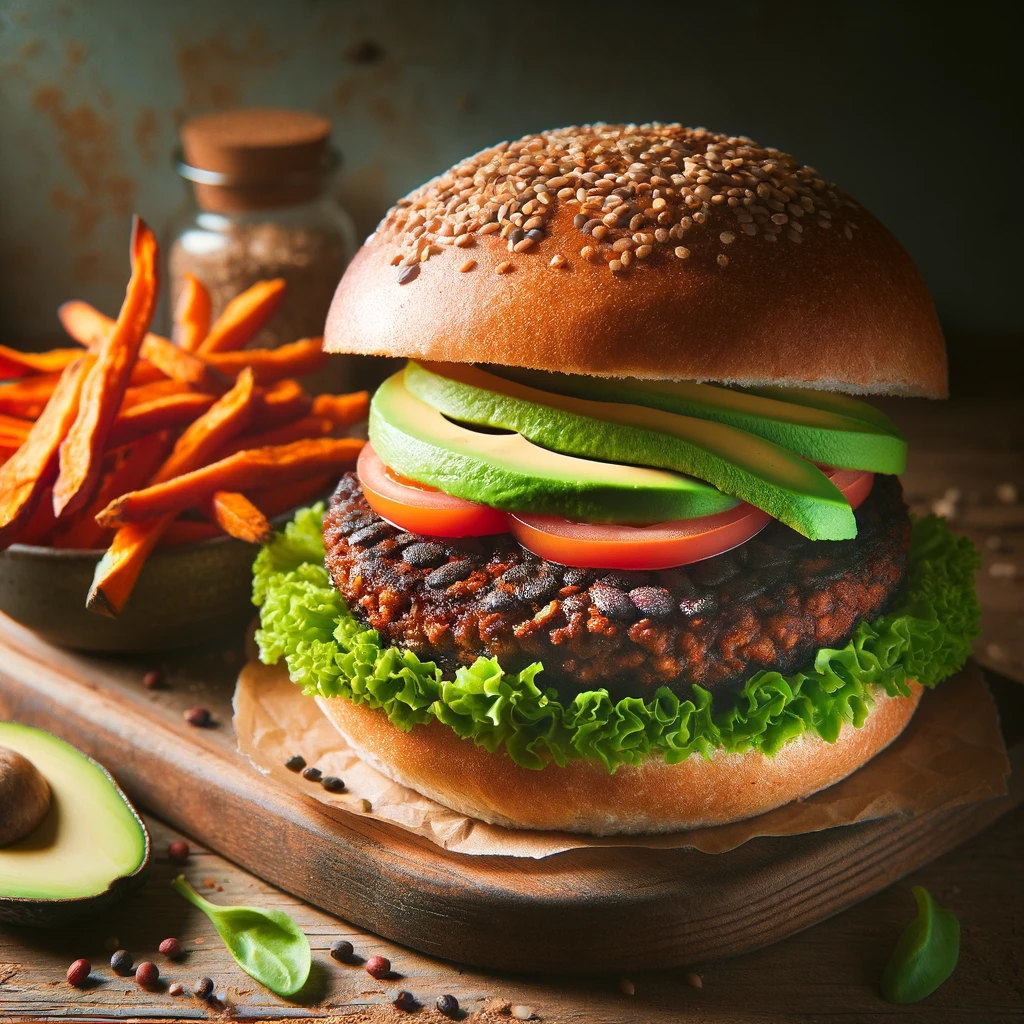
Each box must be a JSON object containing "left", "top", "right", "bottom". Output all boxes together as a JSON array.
[{"left": 509, "top": 470, "right": 874, "bottom": 569}]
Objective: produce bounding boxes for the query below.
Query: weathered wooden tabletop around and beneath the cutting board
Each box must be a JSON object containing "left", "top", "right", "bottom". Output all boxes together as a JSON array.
[{"left": 0, "top": 396, "right": 1024, "bottom": 1024}]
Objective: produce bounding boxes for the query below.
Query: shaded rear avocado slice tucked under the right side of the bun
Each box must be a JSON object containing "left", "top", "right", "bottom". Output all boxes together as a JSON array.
[{"left": 488, "top": 367, "right": 906, "bottom": 475}]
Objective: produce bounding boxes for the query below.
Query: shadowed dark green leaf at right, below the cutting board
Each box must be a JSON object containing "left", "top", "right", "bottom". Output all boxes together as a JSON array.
[{"left": 882, "top": 886, "right": 959, "bottom": 1002}]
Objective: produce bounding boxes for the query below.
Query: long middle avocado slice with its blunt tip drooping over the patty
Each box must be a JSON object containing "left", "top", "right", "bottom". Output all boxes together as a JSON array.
[{"left": 403, "top": 361, "right": 857, "bottom": 541}]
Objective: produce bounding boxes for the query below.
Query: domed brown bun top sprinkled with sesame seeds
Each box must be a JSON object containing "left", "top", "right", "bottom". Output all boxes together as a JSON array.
[{"left": 325, "top": 124, "right": 947, "bottom": 397}]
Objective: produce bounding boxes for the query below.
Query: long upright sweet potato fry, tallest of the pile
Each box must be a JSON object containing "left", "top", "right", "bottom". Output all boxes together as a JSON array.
[{"left": 53, "top": 217, "right": 158, "bottom": 517}]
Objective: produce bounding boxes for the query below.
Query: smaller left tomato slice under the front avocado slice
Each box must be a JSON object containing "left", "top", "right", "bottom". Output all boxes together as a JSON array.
[{"left": 355, "top": 444, "right": 509, "bottom": 537}]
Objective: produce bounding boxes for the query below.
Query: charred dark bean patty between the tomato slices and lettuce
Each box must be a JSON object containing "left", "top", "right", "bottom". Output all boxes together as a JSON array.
[{"left": 324, "top": 473, "right": 910, "bottom": 699}]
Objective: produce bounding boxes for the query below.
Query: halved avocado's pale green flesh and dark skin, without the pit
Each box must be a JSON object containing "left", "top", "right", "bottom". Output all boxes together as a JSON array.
[{"left": 0, "top": 722, "right": 150, "bottom": 927}]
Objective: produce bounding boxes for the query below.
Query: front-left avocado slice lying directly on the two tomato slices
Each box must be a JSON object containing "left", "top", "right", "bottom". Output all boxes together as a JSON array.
[{"left": 370, "top": 371, "right": 737, "bottom": 522}]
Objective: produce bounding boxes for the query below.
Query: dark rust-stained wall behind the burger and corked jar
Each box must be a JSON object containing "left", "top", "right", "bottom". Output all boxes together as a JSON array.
[{"left": 0, "top": 0, "right": 1024, "bottom": 376}]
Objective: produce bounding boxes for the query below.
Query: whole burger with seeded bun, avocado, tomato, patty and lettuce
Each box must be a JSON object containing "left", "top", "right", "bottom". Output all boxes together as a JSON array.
[{"left": 254, "top": 124, "right": 978, "bottom": 835}]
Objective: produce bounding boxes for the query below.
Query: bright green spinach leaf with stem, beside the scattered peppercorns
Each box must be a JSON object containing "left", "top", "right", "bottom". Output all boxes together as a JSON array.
[{"left": 171, "top": 874, "right": 310, "bottom": 996}]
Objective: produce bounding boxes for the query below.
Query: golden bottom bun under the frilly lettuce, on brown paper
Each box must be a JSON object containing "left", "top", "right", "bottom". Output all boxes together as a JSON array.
[{"left": 316, "top": 682, "right": 922, "bottom": 836}]
